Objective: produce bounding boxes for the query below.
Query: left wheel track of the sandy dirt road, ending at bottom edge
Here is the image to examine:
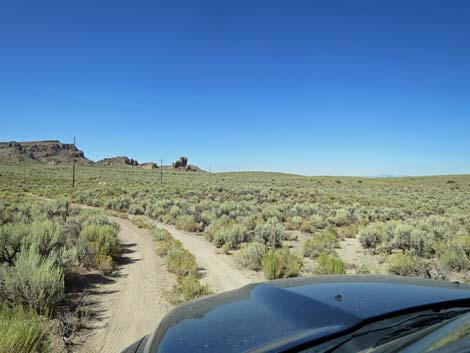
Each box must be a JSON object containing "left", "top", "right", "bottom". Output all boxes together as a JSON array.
[{"left": 79, "top": 217, "right": 175, "bottom": 353}]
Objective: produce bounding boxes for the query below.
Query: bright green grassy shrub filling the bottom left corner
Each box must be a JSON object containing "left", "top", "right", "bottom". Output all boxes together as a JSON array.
[{"left": 0, "top": 303, "right": 51, "bottom": 353}]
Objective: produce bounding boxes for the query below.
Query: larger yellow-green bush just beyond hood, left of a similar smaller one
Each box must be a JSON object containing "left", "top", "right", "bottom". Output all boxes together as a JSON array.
[{"left": 263, "top": 247, "right": 302, "bottom": 280}]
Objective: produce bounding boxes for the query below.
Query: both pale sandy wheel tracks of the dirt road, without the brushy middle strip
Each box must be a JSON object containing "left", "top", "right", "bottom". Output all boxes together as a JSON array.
[{"left": 77, "top": 217, "right": 262, "bottom": 353}]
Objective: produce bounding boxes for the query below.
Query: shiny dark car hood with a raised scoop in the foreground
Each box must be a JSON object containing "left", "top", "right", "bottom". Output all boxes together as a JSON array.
[{"left": 139, "top": 276, "right": 470, "bottom": 353}]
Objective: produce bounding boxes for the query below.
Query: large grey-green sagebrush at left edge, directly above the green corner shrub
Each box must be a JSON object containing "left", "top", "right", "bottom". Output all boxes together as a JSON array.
[{"left": 0, "top": 247, "right": 64, "bottom": 312}]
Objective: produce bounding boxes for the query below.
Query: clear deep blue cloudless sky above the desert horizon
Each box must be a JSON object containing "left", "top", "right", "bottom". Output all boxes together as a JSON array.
[{"left": 0, "top": 0, "right": 470, "bottom": 175}]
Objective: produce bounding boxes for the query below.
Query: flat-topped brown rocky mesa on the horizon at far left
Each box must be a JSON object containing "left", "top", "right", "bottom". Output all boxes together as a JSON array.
[{"left": 0, "top": 140, "right": 93, "bottom": 164}]
